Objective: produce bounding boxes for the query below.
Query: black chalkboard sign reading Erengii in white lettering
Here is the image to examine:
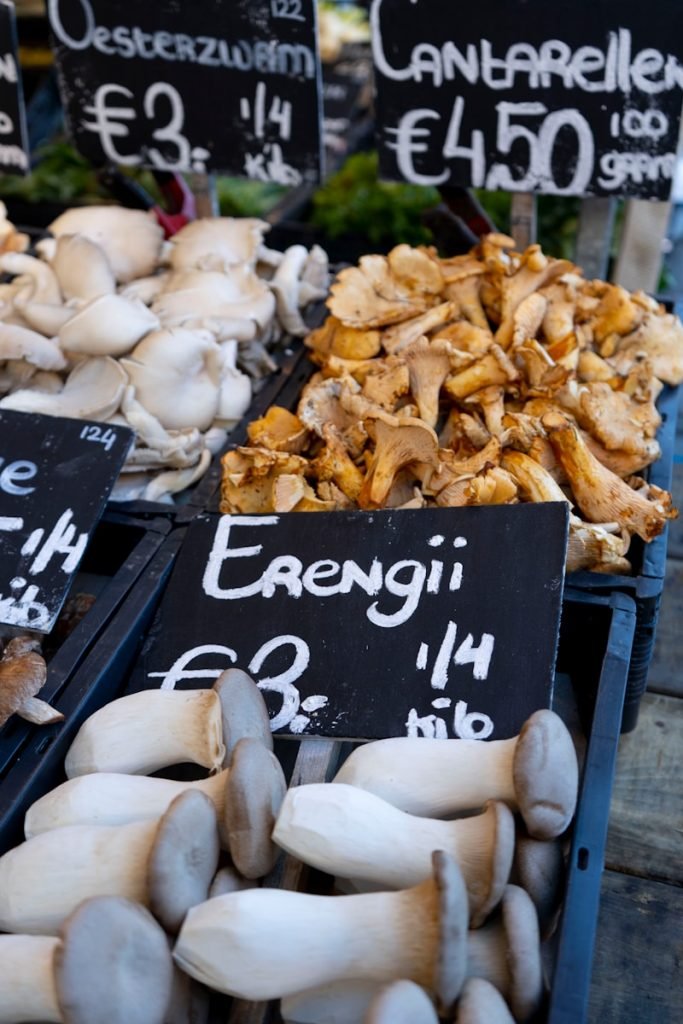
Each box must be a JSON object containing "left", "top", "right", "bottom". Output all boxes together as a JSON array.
[{"left": 140, "top": 503, "right": 568, "bottom": 739}]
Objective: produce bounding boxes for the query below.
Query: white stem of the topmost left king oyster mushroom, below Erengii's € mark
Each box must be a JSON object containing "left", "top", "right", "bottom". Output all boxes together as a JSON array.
[{"left": 65, "top": 690, "right": 225, "bottom": 778}]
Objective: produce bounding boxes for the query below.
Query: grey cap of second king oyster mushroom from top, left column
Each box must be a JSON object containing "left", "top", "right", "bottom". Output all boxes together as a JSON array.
[{"left": 222, "top": 737, "right": 287, "bottom": 879}]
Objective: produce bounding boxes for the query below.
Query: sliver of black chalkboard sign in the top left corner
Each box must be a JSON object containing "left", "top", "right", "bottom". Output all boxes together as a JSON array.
[{"left": 0, "top": 0, "right": 30, "bottom": 174}]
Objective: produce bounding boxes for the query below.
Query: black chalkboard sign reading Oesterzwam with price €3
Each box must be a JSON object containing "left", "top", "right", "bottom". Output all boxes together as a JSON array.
[{"left": 47, "top": 0, "right": 322, "bottom": 185}]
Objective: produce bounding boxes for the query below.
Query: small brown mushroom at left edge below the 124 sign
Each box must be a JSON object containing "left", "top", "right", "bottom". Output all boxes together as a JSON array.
[{"left": 0, "top": 636, "right": 63, "bottom": 727}]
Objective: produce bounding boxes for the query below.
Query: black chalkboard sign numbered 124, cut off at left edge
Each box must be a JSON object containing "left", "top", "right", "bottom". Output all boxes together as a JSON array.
[{"left": 0, "top": 410, "right": 133, "bottom": 633}]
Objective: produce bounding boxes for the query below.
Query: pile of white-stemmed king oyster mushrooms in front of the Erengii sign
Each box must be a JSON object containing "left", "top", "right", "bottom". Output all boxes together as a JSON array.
[{"left": 0, "top": 668, "right": 579, "bottom": 1024}]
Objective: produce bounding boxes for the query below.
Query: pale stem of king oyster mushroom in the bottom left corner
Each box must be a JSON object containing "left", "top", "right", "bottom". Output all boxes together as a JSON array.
[{"left": 0, "top": 935, "right": 61, "bottom": 1024}]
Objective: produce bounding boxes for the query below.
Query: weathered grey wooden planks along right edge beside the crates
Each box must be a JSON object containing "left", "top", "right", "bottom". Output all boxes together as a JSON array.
[{"left": 588, "top": 405, "right": 683, "bottom": 1024}]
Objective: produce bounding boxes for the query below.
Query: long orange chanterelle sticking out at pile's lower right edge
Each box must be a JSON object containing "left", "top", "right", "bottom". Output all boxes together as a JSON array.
[{"left": 540, "top": 411, "right": 678, "bottom": 541}]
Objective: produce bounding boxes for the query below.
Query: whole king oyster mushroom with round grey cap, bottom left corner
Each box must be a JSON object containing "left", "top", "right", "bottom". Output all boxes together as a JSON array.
[{"left": 0, "top": 896, "right": 173, "bottom": 1024}]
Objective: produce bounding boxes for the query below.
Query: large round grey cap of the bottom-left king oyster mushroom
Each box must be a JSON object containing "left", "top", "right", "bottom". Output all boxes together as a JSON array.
[{"left": 54, "top": 896, "right": 173, "bottom": 1024}]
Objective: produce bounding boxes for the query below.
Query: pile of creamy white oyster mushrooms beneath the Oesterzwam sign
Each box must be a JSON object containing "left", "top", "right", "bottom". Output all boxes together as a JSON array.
[{"left": 0, "top": 198, "right": 329, "bottom": 501}]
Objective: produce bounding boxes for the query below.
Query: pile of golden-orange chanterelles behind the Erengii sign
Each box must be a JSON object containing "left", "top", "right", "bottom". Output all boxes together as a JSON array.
[{"left": 221, "top": 234, "right": 683, "bottom": 572}]
